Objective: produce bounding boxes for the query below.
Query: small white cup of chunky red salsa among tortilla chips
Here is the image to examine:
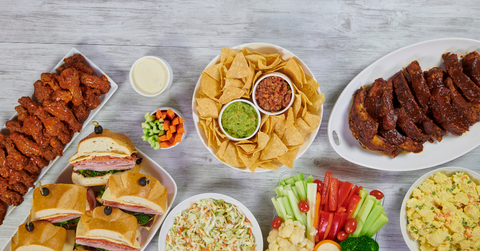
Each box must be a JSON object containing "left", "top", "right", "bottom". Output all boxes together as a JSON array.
[{"left": 252, "top": 72, "right": 295, "bottom": 115}]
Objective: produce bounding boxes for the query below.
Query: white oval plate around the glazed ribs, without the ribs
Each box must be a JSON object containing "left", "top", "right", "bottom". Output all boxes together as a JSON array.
[{"left": 328, "top": 38, "right": 480, "bottom": 171}]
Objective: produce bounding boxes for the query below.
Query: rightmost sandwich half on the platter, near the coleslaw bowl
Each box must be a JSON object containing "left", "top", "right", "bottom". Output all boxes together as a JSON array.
[{"left": 101, "top": 172, "right": 168, "bottom": 230}]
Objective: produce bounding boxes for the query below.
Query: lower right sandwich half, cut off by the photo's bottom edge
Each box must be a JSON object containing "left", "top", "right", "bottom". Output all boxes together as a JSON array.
[{"left": 75, "top": 206, "right": 140, "bottom": 251}]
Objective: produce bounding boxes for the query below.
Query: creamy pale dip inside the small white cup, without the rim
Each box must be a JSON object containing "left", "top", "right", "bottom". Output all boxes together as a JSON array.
[{"left": 132, "top": 57, "right": 168, "bottom": 95}]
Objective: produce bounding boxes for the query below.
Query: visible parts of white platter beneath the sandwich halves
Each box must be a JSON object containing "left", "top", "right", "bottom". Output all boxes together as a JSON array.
[{"left": 2, "top": 149, "right": 177, "bottom": 251}]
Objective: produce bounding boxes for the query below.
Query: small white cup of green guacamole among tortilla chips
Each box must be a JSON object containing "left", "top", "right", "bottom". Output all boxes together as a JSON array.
[{"left": 218, "top": 99, "right": 261, "bottom": 141}]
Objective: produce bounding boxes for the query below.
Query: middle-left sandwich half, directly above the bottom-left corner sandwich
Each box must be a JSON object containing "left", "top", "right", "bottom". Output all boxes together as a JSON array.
[{"left": 30, "top": 184, "right": 96, "bottom": 228}]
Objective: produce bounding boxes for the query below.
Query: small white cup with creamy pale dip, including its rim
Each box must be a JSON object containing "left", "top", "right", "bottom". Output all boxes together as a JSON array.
[{"left": 130, "top": 56, "right": 173, "bottom": 97}]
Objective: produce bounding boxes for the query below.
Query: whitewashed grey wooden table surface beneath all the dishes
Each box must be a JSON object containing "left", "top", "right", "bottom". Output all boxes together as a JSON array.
[{"left": 0, "top": 0, "right": 480, "bottom": 250}]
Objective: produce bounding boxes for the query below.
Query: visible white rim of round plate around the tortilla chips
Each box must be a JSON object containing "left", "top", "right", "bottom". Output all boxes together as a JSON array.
[{"left": 192, "top": 43, "right": 323, "bottom": 173}]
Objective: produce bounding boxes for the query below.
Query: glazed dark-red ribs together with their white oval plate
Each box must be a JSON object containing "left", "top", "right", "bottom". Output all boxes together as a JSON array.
[{"left": 328, "top": 39, "right": 480, "bottom": 171}]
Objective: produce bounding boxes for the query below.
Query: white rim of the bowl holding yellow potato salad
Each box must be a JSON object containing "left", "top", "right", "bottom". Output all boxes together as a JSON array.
[{"left": 400, "top": 167, "right": 480, "bottom": 251}]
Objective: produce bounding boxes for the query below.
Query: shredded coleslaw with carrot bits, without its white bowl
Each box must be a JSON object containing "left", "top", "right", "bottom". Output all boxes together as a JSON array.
[{"left": 165, "top": 199, "right": 257, "bottom": 251}]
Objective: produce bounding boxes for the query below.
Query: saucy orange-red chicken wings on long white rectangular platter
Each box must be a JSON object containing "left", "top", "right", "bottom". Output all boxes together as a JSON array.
[{"left": 0, "top": 48, "right": 118, "bottom": 224}]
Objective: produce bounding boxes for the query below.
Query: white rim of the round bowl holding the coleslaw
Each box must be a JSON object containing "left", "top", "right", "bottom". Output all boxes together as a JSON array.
[{"left": 158, "top": 193, "right": 263, "bottom": 251}]
